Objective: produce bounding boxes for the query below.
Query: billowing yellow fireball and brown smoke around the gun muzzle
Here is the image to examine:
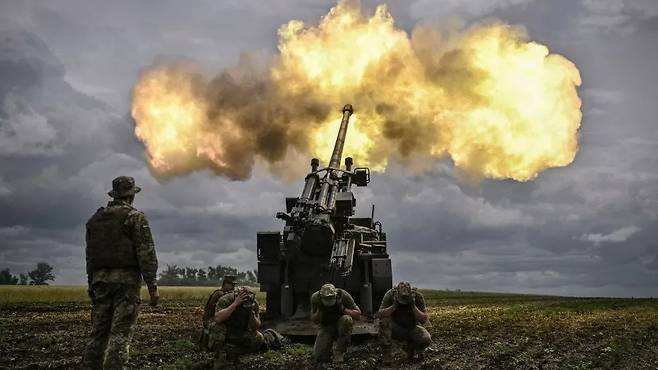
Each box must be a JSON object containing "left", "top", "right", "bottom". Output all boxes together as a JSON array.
[{"left": 132, "top": 2, "right": 581, "bottom": 181}]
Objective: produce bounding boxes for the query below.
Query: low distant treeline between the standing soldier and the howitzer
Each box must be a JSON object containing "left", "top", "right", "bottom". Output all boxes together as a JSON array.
[{"left": 158, "top": 265, "right": 257, "bottom": 286}]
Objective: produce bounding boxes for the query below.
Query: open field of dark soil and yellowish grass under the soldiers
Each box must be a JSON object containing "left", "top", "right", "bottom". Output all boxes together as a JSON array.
[{"left": 0, "top": 286, "right": 658, "bottom": 369}]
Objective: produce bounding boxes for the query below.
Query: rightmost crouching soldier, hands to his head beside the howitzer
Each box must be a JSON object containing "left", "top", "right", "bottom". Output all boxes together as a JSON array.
[{"left": 376, "top": 281, "right": 432, "bottom": 363}]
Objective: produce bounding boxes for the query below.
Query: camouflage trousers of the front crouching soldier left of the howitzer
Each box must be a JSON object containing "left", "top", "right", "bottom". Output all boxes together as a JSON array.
[{"left": 208, "top": 323, "right": 267, "bottom": 369}]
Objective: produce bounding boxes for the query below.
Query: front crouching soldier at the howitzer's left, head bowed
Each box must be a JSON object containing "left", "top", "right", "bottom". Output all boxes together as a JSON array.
[{"left": 208, "top": 287, "right": 283, "bottom": 369}]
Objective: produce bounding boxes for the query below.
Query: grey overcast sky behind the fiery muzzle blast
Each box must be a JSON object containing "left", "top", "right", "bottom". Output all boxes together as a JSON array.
[{"left": 0, "top": 0, "right": 658, "bottom": 297}]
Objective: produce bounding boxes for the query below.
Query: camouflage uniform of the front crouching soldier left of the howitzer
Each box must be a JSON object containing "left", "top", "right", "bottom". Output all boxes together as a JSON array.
[{"left": 208, "top": 287, "right": 268, "bottom": 368}]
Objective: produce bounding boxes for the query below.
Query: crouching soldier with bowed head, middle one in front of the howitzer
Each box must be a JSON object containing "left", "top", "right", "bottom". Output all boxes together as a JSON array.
[{"left": 311, "top": 284, "right": 361, "bottom": 363}]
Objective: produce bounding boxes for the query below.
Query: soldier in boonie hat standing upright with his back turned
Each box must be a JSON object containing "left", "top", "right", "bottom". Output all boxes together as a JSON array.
[{"left": 83, "top": 176, "right": 160, "bottom": 369}]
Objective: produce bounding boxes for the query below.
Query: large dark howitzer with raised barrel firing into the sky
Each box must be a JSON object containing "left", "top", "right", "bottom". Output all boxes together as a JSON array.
[{"left": 257, "top": 104, "right": 392, "bottom": 335}]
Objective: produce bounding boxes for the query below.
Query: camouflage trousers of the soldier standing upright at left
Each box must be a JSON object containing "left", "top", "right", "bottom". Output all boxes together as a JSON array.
[{"left": 82, "top": 282, "right": 141, "bottom": 370}]
